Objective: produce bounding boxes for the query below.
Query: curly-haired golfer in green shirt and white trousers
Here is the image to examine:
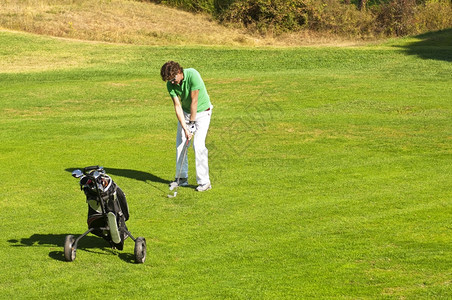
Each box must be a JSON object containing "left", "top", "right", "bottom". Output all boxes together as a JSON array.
[{"left": 160, "top": 61, "right": 213, "bottom": 192}]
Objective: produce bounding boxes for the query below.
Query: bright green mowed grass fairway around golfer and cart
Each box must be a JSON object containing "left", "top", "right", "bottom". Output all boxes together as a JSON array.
[{"left": 0, "top": 31, "right": 452, "bottom": 299}]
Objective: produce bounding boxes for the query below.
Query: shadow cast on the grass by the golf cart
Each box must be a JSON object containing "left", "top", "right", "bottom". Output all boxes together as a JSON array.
[{"left": 8, "top": 234, "right": 134, "bottom": 263}]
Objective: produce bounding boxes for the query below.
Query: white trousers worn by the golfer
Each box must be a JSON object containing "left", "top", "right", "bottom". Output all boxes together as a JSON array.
[{"left": 176, "top": 106, "right": 213, "bottom": 184}]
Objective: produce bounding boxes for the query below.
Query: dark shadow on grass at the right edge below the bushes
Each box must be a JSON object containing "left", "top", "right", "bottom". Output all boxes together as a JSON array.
[{"left": 403, "top": 28, "right": 452, "bottom": 62}]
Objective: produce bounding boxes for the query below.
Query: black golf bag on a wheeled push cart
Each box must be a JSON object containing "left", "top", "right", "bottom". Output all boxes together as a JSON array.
[{"left": 64, "top": 166, "right": 146, "bottom": 263}]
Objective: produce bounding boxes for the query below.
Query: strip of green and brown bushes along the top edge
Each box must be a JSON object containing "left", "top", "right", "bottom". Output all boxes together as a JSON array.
[{"left": 143, "top": 0, "right": 452, "bottom": 38}]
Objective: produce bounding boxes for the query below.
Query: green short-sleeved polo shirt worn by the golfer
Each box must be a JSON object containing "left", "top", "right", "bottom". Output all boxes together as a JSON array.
[{"left": 166, "top": 68, "right": 210, "bottom": 113}]
